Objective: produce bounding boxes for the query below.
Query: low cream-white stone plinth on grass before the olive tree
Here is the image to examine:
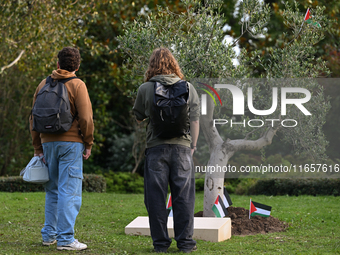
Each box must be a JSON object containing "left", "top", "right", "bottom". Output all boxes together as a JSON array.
[{"left": 125, "top": 216, "right": 231, "bottom": 242}]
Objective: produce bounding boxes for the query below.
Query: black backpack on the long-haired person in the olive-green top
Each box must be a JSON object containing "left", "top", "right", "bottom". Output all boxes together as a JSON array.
[{"left": 150, "top": 80, "right": 190, "bottom": 139}]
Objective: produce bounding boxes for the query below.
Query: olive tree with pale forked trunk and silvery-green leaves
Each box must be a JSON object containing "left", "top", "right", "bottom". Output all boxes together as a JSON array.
[{"left": 119, "top": 0, "right": 329, "bottom": 217}]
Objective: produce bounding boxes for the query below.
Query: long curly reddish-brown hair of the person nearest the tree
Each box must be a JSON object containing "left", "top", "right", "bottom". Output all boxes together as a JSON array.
[{"left": 145, "top": 47, "right": 184, "bottom": 81}]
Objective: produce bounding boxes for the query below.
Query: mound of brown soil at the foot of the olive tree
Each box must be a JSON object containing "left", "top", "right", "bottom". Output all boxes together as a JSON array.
[{"left": 195, "top": 206, "right": 288, "bottom": 235}]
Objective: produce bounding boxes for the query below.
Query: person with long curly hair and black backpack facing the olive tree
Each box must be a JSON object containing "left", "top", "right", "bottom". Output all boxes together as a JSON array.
[{"left": 133, "top": 48, "right": 200, "bottom": 253}]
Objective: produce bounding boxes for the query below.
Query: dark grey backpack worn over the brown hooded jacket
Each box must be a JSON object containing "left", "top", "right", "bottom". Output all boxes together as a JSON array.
[{"left": 32, "top": 76, "right": 79, "bottom": 134}]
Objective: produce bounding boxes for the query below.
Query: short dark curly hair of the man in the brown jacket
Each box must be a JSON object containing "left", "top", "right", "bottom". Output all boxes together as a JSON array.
[{"left": 58, "top": 47, "right": 80, "bottom": 72}]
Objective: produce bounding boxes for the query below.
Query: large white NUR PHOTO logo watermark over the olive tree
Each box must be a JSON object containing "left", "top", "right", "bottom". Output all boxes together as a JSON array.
[{"left": 197, "top": 79, "right": 312, "bottom": 127}]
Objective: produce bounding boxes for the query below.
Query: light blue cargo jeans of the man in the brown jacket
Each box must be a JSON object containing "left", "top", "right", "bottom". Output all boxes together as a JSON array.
[{"left": 41, "top": 142, "right": 84, "bottom": 246}]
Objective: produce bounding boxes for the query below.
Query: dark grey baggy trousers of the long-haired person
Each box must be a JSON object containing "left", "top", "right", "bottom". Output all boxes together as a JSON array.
[{"left": 144, "top": 144, "right": 196, "bottom": 250}]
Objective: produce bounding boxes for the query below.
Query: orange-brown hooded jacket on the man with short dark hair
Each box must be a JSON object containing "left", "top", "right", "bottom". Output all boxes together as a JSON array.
[{"left": 30, "top": 69, "right": 94, "bottom": 154}]
